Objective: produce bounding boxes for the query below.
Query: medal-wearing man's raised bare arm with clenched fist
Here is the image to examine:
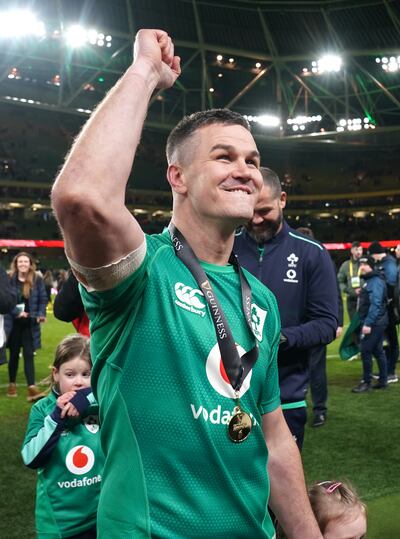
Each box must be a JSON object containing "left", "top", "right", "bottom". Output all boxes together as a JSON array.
[{"left": 52, "top": 29, "right": 180, "bottom": 268}]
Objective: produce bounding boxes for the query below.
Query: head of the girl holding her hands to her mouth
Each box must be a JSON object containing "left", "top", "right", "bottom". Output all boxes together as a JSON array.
[{"left": 52, "top": 333, "right": 92, "bottom": 395}]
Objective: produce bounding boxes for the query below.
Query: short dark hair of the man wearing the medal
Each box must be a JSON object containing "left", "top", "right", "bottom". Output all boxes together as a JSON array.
[{"left": 166, "top": 109, "right": 250, "bottom": 163}]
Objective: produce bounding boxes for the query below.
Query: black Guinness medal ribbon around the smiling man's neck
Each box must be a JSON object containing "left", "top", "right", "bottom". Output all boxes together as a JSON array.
[{"left": 168, "top": 223, "right": 259, "bottom": 391}]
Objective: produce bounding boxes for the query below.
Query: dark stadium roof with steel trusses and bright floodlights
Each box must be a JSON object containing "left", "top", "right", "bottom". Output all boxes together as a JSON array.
[{"left": 0, "top": 0, "right": 400, "bottom": 148}]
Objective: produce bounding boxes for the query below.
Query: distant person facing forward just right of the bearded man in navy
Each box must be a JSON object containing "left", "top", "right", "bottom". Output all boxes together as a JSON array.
[{"left": 338, "top": 241, "right": 363, "bottom": 321}]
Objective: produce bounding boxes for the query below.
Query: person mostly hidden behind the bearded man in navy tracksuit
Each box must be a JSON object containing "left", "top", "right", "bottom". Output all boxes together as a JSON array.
[{"left": 297, "top": 227, "right": 343, "bottom": 427}]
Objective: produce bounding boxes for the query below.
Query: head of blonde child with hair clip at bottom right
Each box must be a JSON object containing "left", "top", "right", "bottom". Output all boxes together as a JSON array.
[{"left": 308, "top": 481, "right": 367, "bottom": 539}]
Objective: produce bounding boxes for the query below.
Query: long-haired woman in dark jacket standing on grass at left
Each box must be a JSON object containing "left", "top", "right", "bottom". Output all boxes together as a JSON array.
[{"left": 5, "top": 252, "right": 47, "bottom": 402}]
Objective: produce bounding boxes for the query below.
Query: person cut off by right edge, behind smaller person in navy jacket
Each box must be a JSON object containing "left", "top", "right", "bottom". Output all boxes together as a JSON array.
[{"left": 368, "top": 241, "right": 399, "bottom": 384}]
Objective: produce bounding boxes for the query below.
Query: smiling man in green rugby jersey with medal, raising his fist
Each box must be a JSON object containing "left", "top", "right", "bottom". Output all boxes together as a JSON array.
[{"left": 52, "top": 30, "right": 322, "bottom": 539}]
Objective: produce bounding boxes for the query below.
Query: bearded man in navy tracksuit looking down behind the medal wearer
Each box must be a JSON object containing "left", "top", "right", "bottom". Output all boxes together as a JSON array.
[{"left": 234, "top": 168, "right": 338, "bottom": 449}]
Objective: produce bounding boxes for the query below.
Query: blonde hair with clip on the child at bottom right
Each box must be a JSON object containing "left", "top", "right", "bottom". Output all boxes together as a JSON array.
[{"left": 308, "top": 481, "right": 367, "bottom": 533}]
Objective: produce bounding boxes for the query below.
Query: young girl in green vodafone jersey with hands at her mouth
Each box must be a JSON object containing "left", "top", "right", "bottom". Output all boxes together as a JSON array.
[{"left": 22, "top": 333, "right": 104, "bottom": 539}]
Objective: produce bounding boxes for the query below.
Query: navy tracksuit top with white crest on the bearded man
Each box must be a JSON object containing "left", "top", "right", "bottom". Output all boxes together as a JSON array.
[{"left": 234, "top": 222, "right": 338, "bottom": 405}]
